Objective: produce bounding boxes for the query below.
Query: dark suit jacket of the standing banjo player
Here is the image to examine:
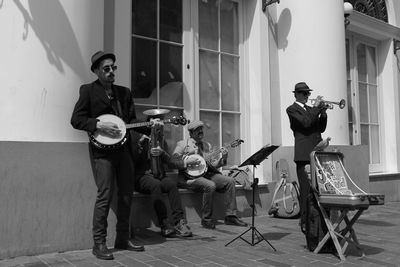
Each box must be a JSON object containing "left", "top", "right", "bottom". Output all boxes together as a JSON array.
[{"left": 71, "top": 80, "right": 141, "bottom": 157}]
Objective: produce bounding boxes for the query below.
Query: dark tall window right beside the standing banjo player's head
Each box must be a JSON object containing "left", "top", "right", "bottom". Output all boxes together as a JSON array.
[{"left": 131, "top": 0, "right": 183, "bottom": 152}]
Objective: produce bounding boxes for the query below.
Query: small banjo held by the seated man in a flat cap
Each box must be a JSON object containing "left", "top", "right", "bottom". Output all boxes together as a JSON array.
[{"left": 185, "top": 139, "right": 244, "bottom": 179}]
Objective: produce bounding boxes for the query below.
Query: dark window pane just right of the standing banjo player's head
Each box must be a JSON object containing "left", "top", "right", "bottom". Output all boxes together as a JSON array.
[{"left": 131, "top": 38, "right": 157, "bottom": 104}]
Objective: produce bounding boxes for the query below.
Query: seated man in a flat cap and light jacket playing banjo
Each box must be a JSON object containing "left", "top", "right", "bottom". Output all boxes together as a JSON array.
[{"left": 172, "top": 120, "right": 247, "bottom": 229}]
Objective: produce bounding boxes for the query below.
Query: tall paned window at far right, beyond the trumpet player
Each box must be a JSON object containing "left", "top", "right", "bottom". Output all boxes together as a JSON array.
[{"left": 346, "top": 38, "right": 382, "bottom": 171}]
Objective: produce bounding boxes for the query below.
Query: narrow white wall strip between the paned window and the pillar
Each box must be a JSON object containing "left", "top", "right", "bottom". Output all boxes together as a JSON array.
[{"left": 241, "top": 0, "right": 279, "bottom": 183}]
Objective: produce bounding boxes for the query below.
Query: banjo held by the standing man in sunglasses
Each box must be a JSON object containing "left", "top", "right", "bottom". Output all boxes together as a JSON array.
[{"left": 89, "top": 114, "right": 187, "bottom": 149}]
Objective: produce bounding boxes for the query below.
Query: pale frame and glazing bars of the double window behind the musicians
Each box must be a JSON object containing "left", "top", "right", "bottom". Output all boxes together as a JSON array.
[{"left": 128, "top": 0, "right": 248, "bottom": 166}]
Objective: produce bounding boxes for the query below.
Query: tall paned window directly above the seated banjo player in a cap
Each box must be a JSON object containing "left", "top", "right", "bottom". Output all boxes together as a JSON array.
[{"left": 198, "top": 0, "right": 240, "bottom": 168}]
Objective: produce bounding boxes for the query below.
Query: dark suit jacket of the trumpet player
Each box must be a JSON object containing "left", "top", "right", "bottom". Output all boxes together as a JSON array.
[{"left": 286, "top": 103, "right": 328, "bottom": 161}]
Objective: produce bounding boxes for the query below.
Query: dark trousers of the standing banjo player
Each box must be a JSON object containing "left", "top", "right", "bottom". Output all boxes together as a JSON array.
[{"left": 93, "top": 149, "right": 134, "bottom": 243}]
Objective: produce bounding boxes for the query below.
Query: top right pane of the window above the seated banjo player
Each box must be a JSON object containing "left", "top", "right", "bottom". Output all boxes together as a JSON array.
[{"left": 220, "top": 0, "right": 239, "bottom": 54}]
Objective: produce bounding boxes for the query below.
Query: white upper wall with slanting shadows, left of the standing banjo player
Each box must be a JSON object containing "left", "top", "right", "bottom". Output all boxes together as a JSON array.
[{"left": 0, "top": 0, "right": 104, "bottom": 142}]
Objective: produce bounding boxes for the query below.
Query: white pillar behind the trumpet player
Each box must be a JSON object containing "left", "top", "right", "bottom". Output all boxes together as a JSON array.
[{"left": 277, "top": 0, "right": 349, "bottom": 145}]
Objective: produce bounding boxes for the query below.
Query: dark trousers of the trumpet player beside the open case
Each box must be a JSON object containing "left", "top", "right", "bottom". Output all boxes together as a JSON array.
[{"left": 296, "top": 161, "right": 311, "bottom": 230}]
